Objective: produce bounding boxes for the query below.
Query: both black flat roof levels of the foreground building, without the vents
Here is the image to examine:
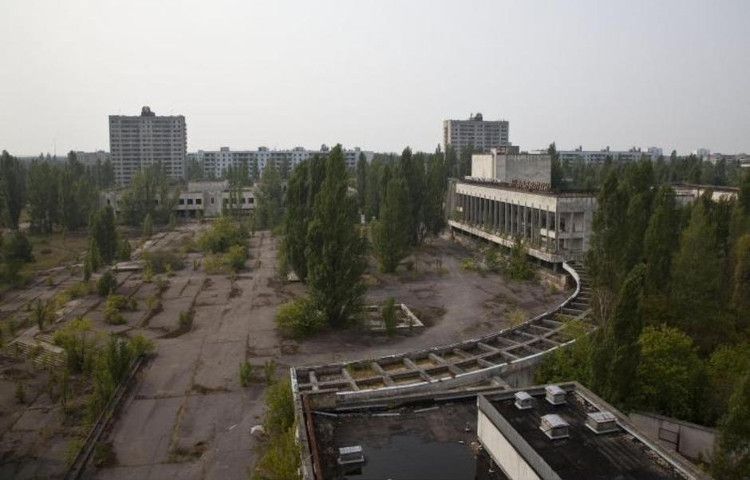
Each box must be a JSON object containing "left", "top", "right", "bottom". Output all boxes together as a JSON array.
[{"left": 302, "top": 382, "right": 707, "bottom": 480}]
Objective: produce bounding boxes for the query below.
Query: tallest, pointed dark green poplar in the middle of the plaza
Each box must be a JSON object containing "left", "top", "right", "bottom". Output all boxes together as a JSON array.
[{"left": 306, "top": 145, "right": 366, "bottom": 326}]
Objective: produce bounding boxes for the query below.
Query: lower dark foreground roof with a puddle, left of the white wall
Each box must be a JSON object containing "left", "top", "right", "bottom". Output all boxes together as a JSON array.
[{"left": 313, "top": 397, "right": 508, "bottom": 480}]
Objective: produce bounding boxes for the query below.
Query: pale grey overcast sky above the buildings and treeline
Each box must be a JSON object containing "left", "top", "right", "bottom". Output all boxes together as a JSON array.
[{"left": 0, "top": 0, "right": 750, "bottom": 155}]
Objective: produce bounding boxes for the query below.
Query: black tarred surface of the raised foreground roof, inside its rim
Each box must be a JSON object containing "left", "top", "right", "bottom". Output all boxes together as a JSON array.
[{"left": 490, "top": 390, "right": 690, "bottom": 480}]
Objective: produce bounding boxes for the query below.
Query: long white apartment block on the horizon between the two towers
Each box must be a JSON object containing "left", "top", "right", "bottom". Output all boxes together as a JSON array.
[{"left": 187, "top": 145, "right": 375, "bottom": 178}]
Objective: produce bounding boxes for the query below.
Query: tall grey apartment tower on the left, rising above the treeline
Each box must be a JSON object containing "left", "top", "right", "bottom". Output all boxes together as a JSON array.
[{"left": 109, "top": 107, "right": 187, "bottom": 185}]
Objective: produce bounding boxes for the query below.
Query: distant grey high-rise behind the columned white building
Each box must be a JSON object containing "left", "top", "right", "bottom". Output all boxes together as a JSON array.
[{"left": 443, "top": 113, "right": 510, "bottom": 152}]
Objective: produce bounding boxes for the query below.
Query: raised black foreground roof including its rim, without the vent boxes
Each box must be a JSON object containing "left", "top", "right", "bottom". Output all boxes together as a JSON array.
[{"left": 479, "top": 384, "right": 703, "bottom": 480}]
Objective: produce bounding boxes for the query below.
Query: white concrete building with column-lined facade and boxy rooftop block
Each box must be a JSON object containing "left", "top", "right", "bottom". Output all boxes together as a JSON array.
[{"left": 446, "top": 152, "right": 596, "bottom": 264}]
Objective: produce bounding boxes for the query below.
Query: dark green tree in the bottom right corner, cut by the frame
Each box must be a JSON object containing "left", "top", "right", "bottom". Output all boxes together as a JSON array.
[{"left": 711, "top": 370, "right": 750, "bottom": 480}]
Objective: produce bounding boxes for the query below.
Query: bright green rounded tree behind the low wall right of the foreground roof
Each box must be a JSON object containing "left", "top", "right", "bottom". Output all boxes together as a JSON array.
[{"left": 636, "top": 326, "right": 703, "bottom": 419}]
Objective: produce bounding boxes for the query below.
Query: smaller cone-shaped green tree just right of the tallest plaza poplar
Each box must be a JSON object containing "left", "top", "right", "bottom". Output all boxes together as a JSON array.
[{"left": 373, "top": 177, "right": 412, "bottom": 273}]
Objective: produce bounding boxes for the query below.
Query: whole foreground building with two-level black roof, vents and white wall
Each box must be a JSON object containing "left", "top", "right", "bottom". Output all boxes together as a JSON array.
[{"left": 296, "top": 382, "right": 707, "bottom": 480}]
